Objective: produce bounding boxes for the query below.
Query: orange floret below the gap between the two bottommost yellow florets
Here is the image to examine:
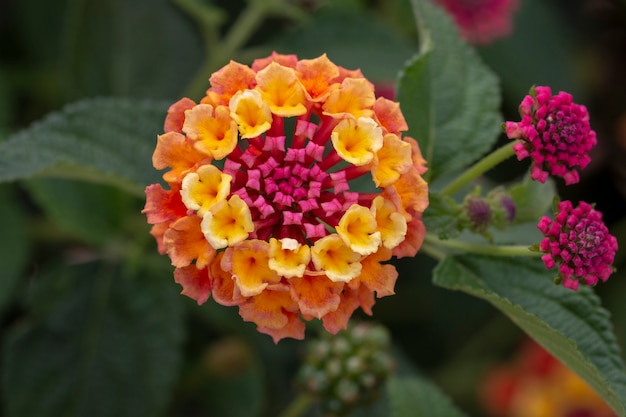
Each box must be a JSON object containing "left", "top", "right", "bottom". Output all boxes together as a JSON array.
[{"left": 289, "top": 275, "right": 344, "bottom": 319}]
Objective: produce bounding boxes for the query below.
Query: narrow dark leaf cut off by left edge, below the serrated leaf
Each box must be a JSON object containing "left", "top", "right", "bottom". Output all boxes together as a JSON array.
[{"left": 0, "top": 186, "right": 30, "bottom": 312}]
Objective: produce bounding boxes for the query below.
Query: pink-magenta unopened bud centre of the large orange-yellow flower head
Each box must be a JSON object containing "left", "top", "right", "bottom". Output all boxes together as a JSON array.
[{"left": 224, "top": 114, "right": 373, "bottom": 243}]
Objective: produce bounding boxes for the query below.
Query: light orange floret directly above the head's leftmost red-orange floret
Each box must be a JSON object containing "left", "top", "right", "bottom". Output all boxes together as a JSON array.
[{"left": 152, "top": 132, "right": 210, "bottom": 183}]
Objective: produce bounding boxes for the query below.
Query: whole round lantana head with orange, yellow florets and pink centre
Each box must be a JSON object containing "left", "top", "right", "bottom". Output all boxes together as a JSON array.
[{"left": 143, "top": 53, "right": 428, "bottom": 342}]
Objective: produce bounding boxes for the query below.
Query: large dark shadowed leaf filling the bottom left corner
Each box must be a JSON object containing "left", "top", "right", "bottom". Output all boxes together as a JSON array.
[{"left": 2, "top": 263, "right": 183, "bottom": 417}]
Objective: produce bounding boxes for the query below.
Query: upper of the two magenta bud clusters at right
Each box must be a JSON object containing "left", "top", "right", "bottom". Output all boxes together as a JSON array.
[{"left": 504, "top": 87, "right": 597, "bottom": 185}]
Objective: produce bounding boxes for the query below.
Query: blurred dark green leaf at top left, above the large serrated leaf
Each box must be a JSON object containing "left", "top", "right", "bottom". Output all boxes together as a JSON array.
[{"left": 12, "top": 0, "right": 202, "bottom": 102}]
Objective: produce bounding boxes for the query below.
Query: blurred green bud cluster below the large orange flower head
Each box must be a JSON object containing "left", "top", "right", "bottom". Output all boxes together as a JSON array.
[{"left": 298, "top": 322, "right": 393, "bottom": 416}]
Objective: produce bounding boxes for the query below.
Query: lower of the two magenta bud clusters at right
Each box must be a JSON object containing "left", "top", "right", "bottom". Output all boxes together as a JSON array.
[{"left": 537, "top": 201, "right": 617, "bottom": 291}]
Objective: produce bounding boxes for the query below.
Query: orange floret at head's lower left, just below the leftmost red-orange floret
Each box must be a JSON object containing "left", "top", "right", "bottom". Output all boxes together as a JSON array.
[{"left": 163, "top": 215, "right": 215, "bottom": 269}]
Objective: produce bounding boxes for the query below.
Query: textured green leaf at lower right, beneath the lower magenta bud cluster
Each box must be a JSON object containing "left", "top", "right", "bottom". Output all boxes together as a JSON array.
[{"left": 434, "top": 255, "right": 626, "bottom": 416}]
